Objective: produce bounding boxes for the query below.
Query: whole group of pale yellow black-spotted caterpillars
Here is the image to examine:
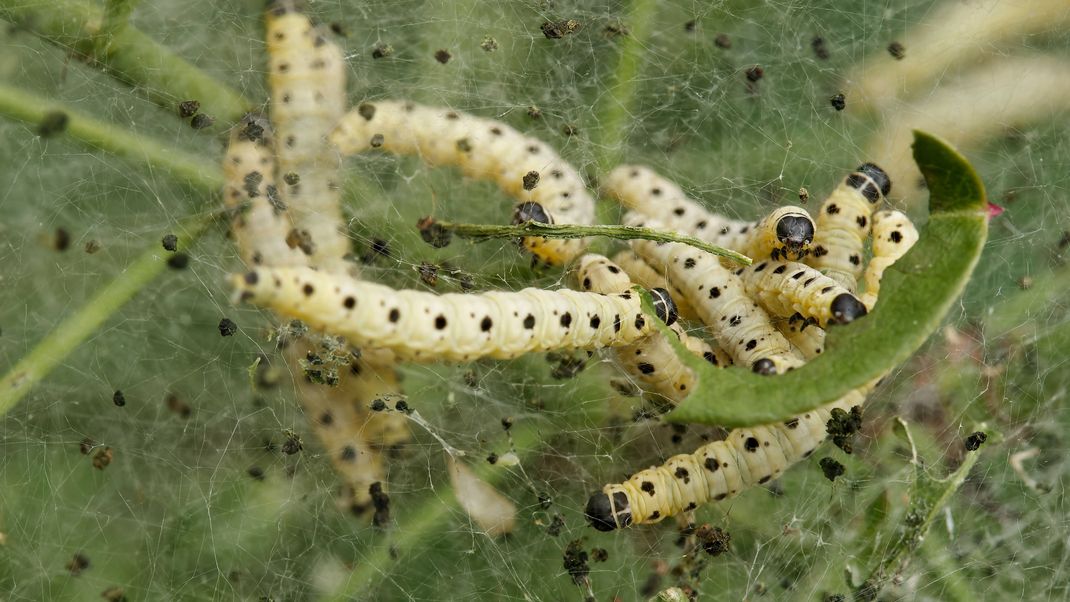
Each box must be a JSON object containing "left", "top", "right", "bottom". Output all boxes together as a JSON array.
[{"left": 225, "top": 0, "right": 917, "bottom": 530}]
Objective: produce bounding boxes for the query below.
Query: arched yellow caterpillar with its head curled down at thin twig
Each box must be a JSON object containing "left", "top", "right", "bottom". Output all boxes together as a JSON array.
[{"left": 331, "top": 101, "right": 595, "bottom": 264}]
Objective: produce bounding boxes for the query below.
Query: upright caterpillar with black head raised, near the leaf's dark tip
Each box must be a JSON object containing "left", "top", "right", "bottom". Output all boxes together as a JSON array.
[{"left": 805, "top": 163, "right": 891, "bottom": 292}]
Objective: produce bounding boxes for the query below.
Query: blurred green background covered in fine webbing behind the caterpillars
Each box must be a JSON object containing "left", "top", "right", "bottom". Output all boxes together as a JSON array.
[{"left": 0, "top": 0, "right": 1070, "bottom": 600}]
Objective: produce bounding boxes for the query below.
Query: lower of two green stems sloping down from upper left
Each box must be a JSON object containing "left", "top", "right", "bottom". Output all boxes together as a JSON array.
[{"left": 0, "top": 83, "right": 223, "bottom": 190}]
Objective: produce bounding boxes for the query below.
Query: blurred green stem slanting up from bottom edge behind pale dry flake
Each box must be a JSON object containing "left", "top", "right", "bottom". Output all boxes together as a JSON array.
[{"left": 325, "top": 422, "right": 546, "bottom": 601}]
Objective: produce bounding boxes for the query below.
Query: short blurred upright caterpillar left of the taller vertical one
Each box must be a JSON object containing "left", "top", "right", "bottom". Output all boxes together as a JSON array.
[{"left": 223, "top": 113, "right": 306, "bottom": 266}]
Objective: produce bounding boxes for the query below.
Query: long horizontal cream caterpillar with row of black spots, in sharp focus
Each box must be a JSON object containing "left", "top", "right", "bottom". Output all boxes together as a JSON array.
[{"left": 232, "top": 267, "right": 676, "bottom": 361}]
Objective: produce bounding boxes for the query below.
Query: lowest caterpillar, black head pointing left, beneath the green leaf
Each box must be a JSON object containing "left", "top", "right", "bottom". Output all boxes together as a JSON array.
[{"left": 584, "top": 382, "right": 875, "bottom": 531}]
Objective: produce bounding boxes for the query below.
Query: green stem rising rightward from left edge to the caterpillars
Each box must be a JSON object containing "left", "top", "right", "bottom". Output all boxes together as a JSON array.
[{"left": 0, "top": 214, "right": 215, "bottom": 416}]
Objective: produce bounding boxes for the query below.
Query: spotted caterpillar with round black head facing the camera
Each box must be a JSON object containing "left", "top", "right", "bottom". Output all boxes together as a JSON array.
[{"left": 602, "top": 166, "right": 814, "bottom": 259}]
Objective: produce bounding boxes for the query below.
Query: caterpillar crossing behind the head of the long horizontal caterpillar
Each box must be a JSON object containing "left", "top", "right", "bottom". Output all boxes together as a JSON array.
[{"left": 576, "top": 254, "right": 731, "bottom": 402}]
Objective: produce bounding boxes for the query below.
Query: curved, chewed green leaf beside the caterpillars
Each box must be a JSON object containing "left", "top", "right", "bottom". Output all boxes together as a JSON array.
[{"left": 666, "top": 132, "right": 988, "bottom": 428}]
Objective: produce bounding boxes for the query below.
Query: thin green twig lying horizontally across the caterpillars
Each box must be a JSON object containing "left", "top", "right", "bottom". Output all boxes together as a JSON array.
[{"left": 425, "top": 220, "right": 752, "bottom": 265}]
